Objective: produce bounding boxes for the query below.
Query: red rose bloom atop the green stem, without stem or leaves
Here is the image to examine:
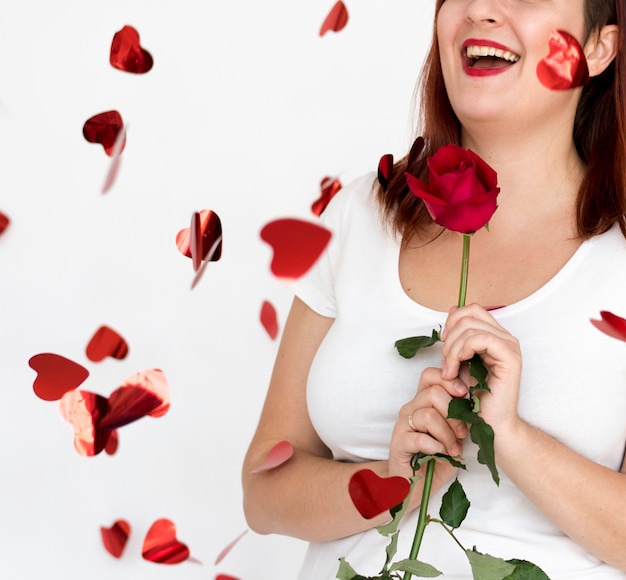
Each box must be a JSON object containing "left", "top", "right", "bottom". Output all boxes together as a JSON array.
[{"left": 405, "top": 145, "right": 500, "bottom": 234}]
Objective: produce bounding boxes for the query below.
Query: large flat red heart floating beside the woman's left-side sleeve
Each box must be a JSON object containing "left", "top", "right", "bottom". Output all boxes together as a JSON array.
[{"left": 261, "top": 218, "right": 331, "bottom": 281}]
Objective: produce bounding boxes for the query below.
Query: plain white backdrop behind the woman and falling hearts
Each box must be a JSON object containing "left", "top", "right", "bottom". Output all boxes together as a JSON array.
[{"left": 0, "top": 0, "right": 434, "bottom": 580}]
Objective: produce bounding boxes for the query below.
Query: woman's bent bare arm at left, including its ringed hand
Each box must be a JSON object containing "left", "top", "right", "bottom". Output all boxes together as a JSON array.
[{"left": 243, "top": 298, "right": 465, "bottom": 541}]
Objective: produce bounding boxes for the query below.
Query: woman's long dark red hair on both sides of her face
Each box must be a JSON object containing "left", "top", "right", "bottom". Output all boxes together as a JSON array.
[{"left": 377, "top": 0, "right": 626, "bottom": 239}]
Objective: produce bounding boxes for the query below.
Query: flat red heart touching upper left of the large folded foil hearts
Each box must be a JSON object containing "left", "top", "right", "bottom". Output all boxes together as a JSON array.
[{"left": 28, "top": 352, "right": 89, "bottom": 401}]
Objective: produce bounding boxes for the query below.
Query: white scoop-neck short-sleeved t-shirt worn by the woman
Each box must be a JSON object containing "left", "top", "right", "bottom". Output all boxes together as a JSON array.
[{"left": 294, "top": 174, "right": 626, "bottom": 580}]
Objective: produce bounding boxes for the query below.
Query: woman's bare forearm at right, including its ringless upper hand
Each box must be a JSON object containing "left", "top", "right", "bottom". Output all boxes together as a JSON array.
[{"left": 443, "top": 305, "right": 626, "bottom": 571}]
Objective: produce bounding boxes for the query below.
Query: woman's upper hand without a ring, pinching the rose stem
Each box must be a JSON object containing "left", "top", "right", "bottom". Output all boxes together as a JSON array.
[{"left": 441, "top": 304, "right": 522, "bottom": 432}]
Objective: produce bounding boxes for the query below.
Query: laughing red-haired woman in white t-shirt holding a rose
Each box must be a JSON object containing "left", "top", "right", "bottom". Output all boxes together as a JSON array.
[{"left": 243, "top": 0, "right": 626, "bottom": 580}]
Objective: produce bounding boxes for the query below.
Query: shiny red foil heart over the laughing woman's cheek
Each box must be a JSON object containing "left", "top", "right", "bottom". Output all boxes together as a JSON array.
[{"left": 537, "top": 30, "right": 589, "bottom": 91}]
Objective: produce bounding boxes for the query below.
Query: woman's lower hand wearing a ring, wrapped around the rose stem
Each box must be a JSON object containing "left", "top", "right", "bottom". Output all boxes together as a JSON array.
[{"left": 389, "top": 367, "right": 467, "bottom": 486}]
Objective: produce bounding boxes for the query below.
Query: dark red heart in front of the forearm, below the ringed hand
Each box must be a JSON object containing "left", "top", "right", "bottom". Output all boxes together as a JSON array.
[{"left": 348, "top": 469, "right": 411, "bottom": 519}]
